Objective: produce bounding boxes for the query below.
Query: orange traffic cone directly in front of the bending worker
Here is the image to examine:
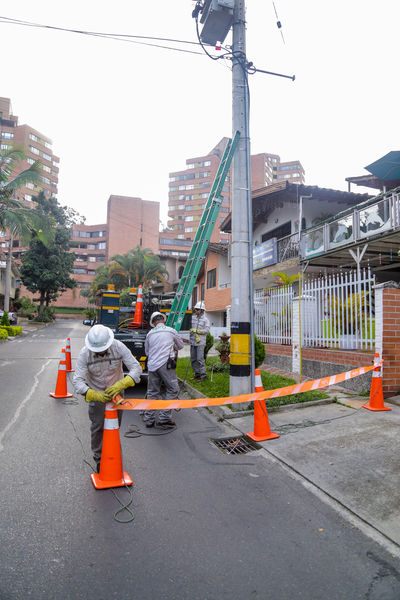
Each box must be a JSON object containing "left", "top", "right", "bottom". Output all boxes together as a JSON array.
[{"left": 90, "top": 402, "right": 133, "bottom": 490}]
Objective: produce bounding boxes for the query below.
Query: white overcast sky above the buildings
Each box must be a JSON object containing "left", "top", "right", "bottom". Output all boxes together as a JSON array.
[{"left": 0, "top": 0, "right": 400, "bottom": 224}]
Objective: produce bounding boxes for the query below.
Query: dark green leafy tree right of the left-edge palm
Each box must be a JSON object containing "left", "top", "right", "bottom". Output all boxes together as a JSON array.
[{"left": 21, "top": 192, "right": 76, "bottom": 320}]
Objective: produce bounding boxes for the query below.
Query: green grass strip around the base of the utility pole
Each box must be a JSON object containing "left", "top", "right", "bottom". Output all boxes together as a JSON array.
[{"left": 176, "top": 356, "right": 329, "bottom": 410}]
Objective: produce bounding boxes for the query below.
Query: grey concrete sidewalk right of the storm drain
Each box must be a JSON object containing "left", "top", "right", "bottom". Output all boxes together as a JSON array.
[{"left": 214, "top": 396, "right": 400, "bottom": 556}]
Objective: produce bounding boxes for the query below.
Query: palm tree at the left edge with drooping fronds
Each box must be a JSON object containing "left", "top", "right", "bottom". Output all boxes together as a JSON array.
[{"left": 0, "top": 148, "right": 52, "bottom": 311}]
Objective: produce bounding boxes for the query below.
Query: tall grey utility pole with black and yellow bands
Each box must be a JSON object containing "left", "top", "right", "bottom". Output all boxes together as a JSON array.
[{"left": 230, "top": 0, "right": 254, "bottom": 396}]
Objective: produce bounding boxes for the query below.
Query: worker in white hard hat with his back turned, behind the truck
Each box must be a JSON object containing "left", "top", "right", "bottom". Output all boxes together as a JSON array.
[{"left": 143, "top": 312, "right": 184, "bottom": 429}]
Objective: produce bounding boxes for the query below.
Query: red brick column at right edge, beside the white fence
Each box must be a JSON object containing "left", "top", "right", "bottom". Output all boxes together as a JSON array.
[{"left": 377, "top": 287, "right": 400, "bottom": 398}]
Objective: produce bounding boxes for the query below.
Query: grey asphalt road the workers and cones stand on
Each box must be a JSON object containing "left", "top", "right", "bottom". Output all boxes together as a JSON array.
[{"left": 0, "top": 320, "right": 400, "bottom": 600}]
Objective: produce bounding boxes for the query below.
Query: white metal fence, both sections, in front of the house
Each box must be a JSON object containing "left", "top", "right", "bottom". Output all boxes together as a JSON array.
[{"left": 254, "top": 269, "right": 375, "bottom": 350}]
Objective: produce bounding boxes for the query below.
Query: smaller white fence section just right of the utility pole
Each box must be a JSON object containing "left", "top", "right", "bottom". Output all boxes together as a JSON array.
[{"left": 254, "top": 285, "right": 293, "bottom": 344}]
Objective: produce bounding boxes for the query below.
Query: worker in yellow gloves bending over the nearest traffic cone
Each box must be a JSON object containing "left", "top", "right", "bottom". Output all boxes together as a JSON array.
[{"left": 73, "top": 325, "right": 142, "bottom": 472}]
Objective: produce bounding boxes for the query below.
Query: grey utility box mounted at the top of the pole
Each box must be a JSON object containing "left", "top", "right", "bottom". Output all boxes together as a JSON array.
[{"left": 200, "top": 0, "right": 235, "bottom": 46}]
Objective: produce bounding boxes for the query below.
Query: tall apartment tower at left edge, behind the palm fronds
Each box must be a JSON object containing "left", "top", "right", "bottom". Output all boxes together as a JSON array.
[{"left": 0, "top": 97, "right": 60, "bottom": 205}]
